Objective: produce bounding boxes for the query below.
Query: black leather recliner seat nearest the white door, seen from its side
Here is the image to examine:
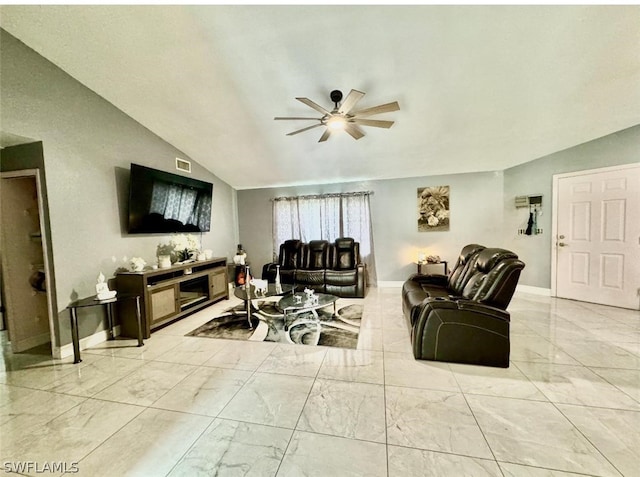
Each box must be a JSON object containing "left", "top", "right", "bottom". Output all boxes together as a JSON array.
[{"left": 402, "top": 244, "right": 525, "bottom": 368}]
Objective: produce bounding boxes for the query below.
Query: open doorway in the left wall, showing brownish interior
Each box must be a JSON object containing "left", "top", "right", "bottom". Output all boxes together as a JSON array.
[{"left": 0, "top": 169, "right": 55, "bottom": 353}]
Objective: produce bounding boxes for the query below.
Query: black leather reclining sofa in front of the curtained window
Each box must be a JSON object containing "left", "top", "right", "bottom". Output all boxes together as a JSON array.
[{"left": 262, "top": 237, "right": 366, "bottom": 298}]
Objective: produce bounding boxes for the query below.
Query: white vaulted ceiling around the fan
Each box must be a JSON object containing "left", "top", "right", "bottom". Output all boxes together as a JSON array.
[{"left": 0, "top": 5, "right": 640, "bottom": 189}]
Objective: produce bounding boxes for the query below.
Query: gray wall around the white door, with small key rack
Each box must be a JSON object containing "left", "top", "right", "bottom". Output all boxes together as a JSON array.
[{"left": 503, "top": 126, "right": 640, "bottom": 288}]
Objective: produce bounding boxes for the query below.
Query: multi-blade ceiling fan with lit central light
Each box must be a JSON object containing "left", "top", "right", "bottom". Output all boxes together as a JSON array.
[{"left": 273, "top": 89, "right": 400, "bottom": 142}]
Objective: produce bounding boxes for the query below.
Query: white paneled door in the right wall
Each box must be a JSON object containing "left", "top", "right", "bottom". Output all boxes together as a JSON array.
[{"left": 555, "top": 165, "right": 640, "bottom": 310}]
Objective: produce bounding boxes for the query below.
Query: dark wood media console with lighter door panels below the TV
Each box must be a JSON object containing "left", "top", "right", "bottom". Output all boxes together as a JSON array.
[{"left": 115, "top": 257, "right": 229, "bottom": 338}]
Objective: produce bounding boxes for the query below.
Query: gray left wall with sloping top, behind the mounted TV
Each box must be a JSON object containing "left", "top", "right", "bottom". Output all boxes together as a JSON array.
[{"left": 0, "top": 30, "right": 238, "bottom": 344}]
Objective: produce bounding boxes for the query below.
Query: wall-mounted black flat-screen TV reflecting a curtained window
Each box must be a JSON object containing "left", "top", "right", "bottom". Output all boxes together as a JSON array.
[{"left": 129, "top": 164, "right": 213, "bottom": 234}]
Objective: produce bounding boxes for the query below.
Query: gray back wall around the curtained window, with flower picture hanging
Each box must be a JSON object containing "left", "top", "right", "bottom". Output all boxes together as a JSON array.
[{"left": 238, "top": 172, "right": 503, "bottom": 281}]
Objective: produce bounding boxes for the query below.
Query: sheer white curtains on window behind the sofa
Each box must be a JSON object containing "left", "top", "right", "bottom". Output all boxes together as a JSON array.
[{"left": 273, "top": 192, "right": 377, "bottom": 286}]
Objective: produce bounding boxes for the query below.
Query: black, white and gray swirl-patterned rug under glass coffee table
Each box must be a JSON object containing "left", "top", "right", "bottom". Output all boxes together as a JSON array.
[{"left": 186, "top": 301, "right": 363, "bottom": 349}]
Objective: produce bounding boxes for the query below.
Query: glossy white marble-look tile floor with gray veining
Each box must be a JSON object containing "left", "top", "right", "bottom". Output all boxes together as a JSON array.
[{"left": 0, "top": 288, "right": 640, "bottom": 477}]
